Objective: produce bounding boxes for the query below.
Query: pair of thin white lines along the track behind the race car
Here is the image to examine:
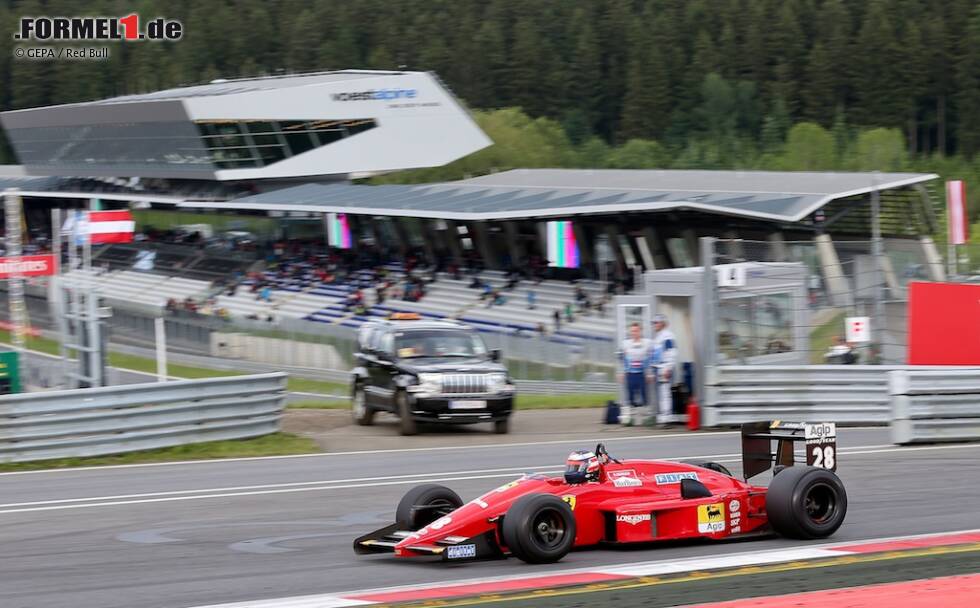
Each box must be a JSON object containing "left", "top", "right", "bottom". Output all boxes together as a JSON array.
[{"left": 0, "top": 444, "right": 980, "bottom": 514}]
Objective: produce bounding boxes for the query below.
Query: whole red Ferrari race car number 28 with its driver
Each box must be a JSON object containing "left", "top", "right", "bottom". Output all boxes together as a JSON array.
[{"left": 354, "top": 421, "right": 847, "bottom": 563}]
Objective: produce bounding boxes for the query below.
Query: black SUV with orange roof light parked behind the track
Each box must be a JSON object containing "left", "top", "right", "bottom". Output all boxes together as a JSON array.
[{"left": 351, "top": 314, "right": 514, "bottom": 435}]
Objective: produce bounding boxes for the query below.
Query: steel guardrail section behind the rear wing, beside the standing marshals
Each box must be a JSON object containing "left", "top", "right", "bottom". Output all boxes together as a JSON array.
[{"left": 701, "top": 365, "right": 896, "bottom": 427}]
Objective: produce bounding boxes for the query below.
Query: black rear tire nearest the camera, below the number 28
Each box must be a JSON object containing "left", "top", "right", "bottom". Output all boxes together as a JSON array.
[{"left": 766, "top": 467, "right": 847, "bottom": 539}]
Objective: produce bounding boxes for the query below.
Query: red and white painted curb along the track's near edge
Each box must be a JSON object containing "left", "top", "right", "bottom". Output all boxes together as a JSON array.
[{"left": 189, "top": 529, "right": 980, "bottom": 608}]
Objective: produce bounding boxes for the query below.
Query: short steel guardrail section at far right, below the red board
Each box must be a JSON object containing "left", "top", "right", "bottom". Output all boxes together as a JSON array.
[{"left": 888, "top": 368, "right": 980, "bottom": 444}]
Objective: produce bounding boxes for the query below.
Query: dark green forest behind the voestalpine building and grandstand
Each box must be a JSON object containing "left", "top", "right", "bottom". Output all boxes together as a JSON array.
[{"left": 0, "top": 0, "right": 980, "bottom": 226}]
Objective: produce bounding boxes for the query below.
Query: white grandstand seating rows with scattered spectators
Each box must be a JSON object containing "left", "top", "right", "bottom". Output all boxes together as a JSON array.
[{"left": 72, "top": 253, "right": 615, "bottom": 344}]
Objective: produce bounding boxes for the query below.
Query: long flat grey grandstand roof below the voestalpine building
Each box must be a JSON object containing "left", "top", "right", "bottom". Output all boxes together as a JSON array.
[{"left": 181, "top": 169, "right": 938, "bottom": 222}]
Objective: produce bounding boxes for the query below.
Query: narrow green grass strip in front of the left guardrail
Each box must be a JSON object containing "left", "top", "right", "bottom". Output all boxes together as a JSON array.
[{"left": 0, "top": 433, "right": 321, "bottom": 471}]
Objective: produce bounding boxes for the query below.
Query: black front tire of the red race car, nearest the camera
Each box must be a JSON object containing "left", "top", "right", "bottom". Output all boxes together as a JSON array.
[{"left": 501, "top": 494, "right": 575, "bottom": 564}]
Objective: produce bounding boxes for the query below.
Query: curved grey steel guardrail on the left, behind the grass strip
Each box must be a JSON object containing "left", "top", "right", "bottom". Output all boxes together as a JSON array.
[{"left": 0, "top": 373, "right": 288, "bottom": 462}]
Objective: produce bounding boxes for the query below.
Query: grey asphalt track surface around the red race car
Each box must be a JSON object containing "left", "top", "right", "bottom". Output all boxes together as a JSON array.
[{"left": 0, "top": 429, "right": 980, "bottom": 608}]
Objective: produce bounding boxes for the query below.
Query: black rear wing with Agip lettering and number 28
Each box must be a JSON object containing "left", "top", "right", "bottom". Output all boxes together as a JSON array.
[{"left": 742, "top": 420, "right": 837, "bottom": 479}]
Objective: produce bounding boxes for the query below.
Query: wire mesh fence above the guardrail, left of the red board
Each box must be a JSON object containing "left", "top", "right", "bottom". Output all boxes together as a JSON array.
[{"left": 712, "top": 236, "right": 936, "bottom": 364}]
